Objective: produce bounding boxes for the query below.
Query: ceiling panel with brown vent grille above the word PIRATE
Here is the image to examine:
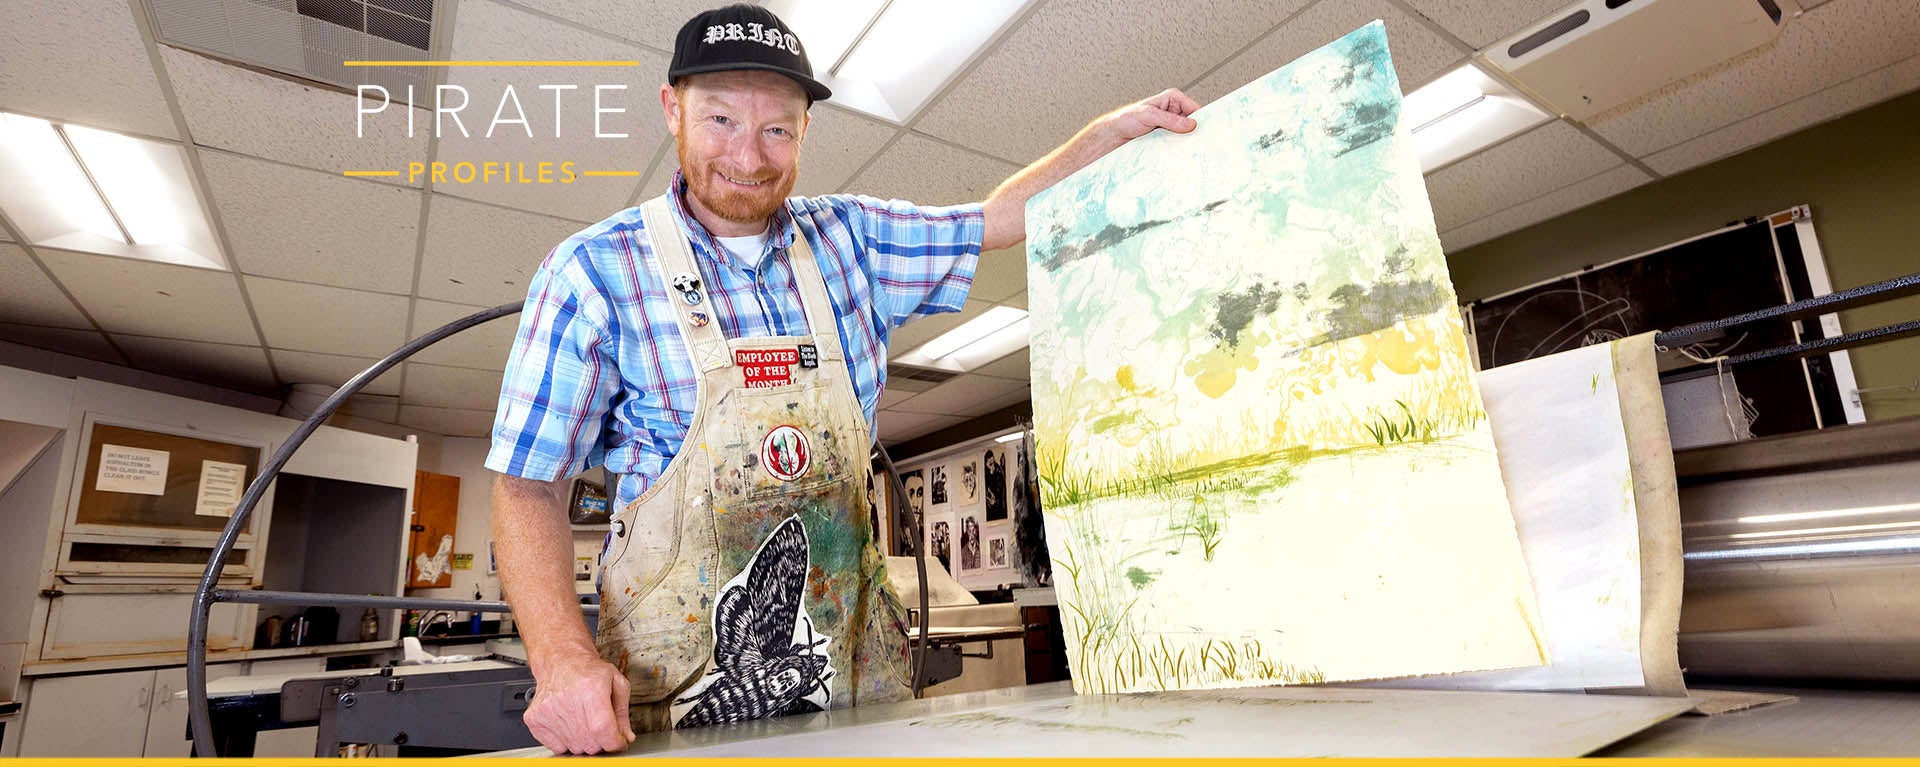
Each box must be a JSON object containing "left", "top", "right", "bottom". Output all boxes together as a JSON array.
[{"left": 146, "top": 0, "right": 434, "bottom": 102}]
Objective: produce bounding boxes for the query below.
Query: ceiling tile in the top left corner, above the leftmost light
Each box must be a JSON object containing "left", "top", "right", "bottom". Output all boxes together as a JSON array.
[{"left": 0, "top": 0, "right": 179, "bottom": 138}]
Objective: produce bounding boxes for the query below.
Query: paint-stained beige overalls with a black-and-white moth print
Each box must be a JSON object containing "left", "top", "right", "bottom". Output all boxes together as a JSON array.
[{"left": 597, "top": 196, "right": 910, "bottom": 732}]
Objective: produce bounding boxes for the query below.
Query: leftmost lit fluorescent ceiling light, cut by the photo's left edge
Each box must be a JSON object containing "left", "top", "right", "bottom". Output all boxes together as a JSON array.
[{"left": 0, "top": 113, "right": 227, "bottom": 269}]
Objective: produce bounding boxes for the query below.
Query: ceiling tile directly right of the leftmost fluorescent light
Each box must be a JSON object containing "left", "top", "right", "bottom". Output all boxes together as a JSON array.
[{"left": 200, "top": 152, "right": 422, "bottom": 294}]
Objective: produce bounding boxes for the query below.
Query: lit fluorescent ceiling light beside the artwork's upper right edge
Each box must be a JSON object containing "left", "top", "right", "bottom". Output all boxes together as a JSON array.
[{"left": 1400, "top": 63, "right": 1553, "bottom": 173}]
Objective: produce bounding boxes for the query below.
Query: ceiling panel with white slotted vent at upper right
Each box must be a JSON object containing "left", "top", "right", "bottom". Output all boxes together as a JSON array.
[{"left": 1480, "top": 0, "right": 1786, "bottom": 119}]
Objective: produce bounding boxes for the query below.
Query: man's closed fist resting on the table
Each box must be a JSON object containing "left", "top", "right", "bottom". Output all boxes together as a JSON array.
[{"left": 522, "top": 654, "right": 634, "bottom": 754}]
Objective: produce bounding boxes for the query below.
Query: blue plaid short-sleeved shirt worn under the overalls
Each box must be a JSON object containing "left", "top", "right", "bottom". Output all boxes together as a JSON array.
[{"left": 486, "top": 173, "right": 987, "bottom": 509}]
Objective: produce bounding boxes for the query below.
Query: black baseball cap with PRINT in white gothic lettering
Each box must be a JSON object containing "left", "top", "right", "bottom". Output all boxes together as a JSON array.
[{"left": 666, "top": 4, "right": 833, "bottom": 102}]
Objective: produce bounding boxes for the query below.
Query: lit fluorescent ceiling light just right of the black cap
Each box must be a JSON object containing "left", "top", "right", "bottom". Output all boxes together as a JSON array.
[{"left": 766, "top": 0, "right": 1031, "bottom": 123}]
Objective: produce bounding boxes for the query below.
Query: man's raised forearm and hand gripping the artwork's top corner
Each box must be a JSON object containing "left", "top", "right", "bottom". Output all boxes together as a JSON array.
[{"left": 979, "top": 88, "right": 1200, "bottom": 252}]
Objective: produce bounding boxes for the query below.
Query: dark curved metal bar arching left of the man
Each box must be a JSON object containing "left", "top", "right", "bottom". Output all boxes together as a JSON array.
[{"left": 186, "top": 304, "right": 520, "bottom": 755}]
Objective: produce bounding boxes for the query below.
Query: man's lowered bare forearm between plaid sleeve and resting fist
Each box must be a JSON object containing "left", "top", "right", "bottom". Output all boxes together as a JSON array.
[{"left": 493, "top": 475, "right": 597, "bottom": 675}]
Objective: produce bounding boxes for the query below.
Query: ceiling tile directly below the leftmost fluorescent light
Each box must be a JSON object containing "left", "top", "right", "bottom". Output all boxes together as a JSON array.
[{"left": 38, "top": 248, "right": 259, "bottom": 346}]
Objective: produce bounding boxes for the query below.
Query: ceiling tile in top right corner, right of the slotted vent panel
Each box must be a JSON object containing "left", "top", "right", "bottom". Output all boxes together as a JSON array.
[{"left": 1588, "top": 0, "right": 1920, "bottom": 158}]
